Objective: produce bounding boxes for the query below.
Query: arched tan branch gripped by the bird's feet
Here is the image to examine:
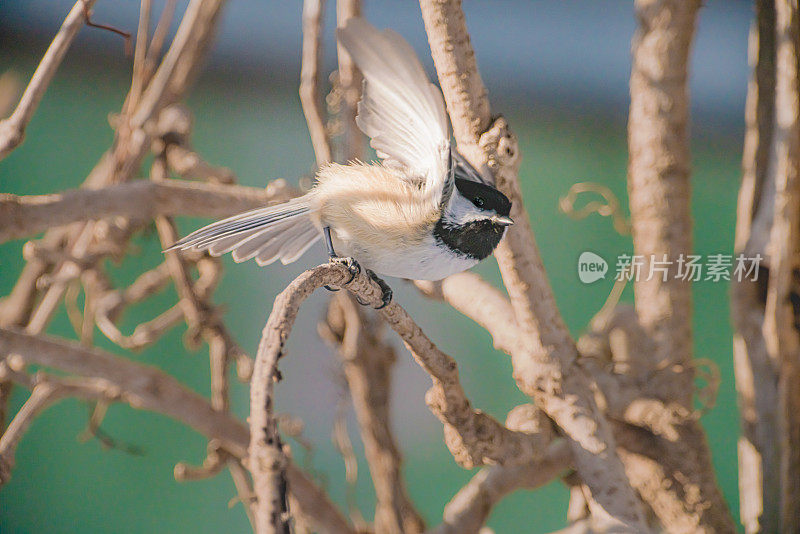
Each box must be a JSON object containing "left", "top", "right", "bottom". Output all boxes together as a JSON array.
[{"left": 250, "top": 263, "right": 549, "bottom": 532}]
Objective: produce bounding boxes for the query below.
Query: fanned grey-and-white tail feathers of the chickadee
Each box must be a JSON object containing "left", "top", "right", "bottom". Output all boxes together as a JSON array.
[{"left": 167, "top": 197, "right": 320, "bottom": 265}]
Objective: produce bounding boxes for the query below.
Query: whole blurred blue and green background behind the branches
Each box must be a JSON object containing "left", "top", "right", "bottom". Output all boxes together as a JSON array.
[{"left": 0, "top": 0, "right": 752, "bottom": 533}]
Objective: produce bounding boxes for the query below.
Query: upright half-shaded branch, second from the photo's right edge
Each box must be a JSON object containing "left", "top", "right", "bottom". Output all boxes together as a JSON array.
[{"left": 731, "top": 0, "right": 781, "bottom": 534}]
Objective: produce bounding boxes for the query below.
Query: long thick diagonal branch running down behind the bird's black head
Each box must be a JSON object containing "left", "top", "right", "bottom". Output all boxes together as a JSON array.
[{"left": 420, "top": 0, "right": 645, "bottom": 530}]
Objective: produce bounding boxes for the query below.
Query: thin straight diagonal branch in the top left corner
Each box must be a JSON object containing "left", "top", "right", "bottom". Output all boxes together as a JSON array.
[{"left": 0, "top": 0, "right": 95, "bottom": 160}]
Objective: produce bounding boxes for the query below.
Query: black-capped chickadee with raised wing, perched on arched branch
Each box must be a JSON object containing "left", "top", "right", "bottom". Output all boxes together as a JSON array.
[{"left": 167, "top": 17, "right": 513, "bottom": 305}]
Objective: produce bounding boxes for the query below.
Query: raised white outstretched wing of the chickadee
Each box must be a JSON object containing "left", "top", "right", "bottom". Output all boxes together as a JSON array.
[{"left": 337, "top": 18, "right": 452, "bottom": 198}]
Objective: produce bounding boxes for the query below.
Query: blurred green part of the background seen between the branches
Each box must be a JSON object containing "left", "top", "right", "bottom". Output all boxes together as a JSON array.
[{"left": 0, "top": 10, "right": 741, "bottom": 533}]
